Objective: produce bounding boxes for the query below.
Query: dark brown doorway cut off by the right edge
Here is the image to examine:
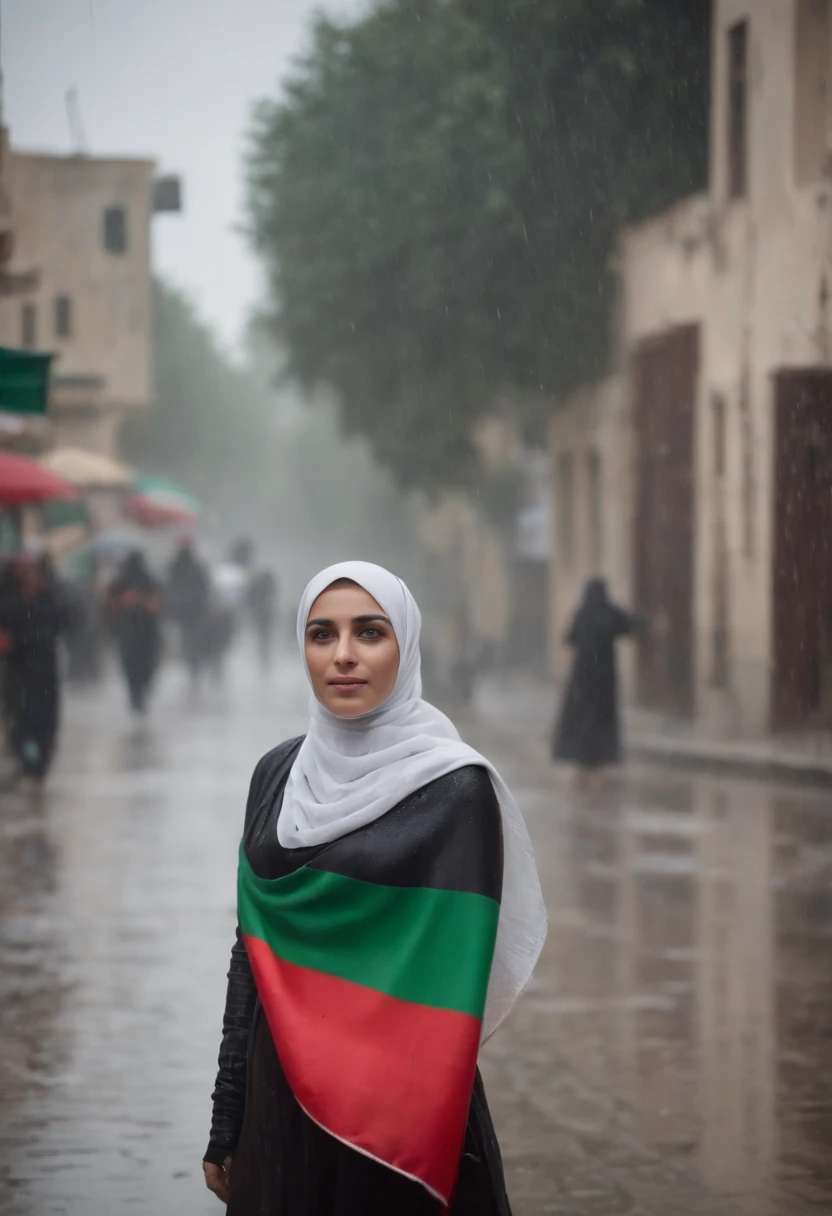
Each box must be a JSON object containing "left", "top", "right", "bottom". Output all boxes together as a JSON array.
[{"left": 771, "top": 370, "right": 832, "bottom": 730}]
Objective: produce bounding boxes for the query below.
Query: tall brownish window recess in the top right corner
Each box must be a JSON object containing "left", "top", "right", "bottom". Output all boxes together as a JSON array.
[{"left": 794, "top": 0, "right": 832, "bottom": 185}]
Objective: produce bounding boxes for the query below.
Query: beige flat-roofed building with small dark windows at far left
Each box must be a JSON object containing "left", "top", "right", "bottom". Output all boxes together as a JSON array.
[{"left": 0, "top": 148, "right": 161, "bottom": 455}]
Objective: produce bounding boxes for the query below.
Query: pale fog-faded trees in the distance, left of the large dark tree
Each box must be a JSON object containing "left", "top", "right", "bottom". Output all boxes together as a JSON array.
[{"left": 125, "top": 281, "right": 423, "bottom": 579}]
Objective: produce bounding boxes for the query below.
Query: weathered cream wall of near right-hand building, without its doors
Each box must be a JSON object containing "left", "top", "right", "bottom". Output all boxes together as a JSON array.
[{"left": 610, "top": 0, "right": 832, "bottom": 733}]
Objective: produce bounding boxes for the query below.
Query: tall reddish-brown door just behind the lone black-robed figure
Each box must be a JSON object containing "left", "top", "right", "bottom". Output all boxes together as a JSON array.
[{"left": 633, "top": 325, "right": 699, "bottom": 716}]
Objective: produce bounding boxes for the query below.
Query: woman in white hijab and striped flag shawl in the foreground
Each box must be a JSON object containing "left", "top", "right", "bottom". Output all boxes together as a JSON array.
[{"left": 203, "top": 562, "right": 546, "bottom": 1216}]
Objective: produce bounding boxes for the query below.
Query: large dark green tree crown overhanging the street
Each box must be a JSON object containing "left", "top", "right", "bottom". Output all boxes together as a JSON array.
[{"left": 248, "top": 0, "right": 708, "bottom": 489}]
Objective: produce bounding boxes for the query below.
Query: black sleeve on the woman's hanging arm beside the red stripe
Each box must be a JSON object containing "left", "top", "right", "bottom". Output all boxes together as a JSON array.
[{"left": 203, "top": 929, "right": 257, "bottom": 1165}]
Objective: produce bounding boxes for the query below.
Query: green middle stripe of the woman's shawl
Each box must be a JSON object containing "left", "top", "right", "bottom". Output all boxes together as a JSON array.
[{"left": 237, "top": 849, "right": 500, "bottom": 1018}]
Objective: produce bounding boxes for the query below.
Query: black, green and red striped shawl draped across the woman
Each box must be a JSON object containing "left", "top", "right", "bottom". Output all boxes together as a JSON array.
[{"left": 238, "top": 769, "right": 501, "bottom": 1205}]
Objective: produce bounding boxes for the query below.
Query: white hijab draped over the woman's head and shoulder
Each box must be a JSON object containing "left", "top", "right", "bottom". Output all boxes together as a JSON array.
[{"left": 277, "top": 562, "right": 546, "bottom": 1040}]
